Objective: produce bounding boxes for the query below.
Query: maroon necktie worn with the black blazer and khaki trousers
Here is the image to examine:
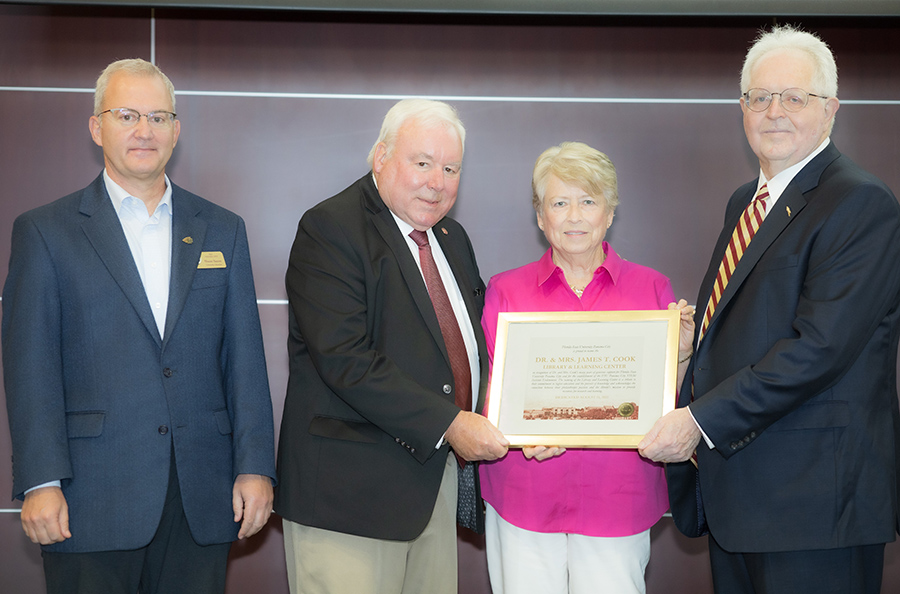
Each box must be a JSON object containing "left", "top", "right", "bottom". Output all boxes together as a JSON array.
[{"left": 409, "top": 230, "right": 472, "bottom": 412}]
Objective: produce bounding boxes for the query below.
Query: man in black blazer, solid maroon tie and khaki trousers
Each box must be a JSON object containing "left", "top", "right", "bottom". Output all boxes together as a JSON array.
[{"left": 275, "top": 99, "right": 507, "bottom": 594}]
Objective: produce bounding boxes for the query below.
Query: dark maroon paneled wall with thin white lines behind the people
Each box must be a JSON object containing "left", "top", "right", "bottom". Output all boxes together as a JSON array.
[{"left": 0, "top": 4, "right": 900, "bottom": 594}]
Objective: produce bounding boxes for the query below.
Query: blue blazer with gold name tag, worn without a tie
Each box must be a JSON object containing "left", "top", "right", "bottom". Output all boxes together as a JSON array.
[{"left": 2, "top": 175, "right": 274, "bottom": 552}]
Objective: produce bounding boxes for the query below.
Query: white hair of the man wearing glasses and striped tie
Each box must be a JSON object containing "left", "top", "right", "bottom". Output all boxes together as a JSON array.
[{"left": 741, "top": 25, "right": 837, "bottom": 97}]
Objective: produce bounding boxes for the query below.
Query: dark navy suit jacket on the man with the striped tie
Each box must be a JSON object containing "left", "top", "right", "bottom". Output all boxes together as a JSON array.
[{"left": 668, "top": 144, "right": 900, "bottom": 552}]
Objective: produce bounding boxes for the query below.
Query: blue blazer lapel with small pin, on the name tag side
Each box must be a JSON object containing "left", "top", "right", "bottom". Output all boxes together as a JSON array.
[{"left": 164, "top": 184, "right": 206, "bottom": 341}]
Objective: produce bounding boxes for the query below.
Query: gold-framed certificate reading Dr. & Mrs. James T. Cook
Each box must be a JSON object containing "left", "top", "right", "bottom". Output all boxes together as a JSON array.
[{"left": 488, "top": 310, "right": 681, "bottom": 448}]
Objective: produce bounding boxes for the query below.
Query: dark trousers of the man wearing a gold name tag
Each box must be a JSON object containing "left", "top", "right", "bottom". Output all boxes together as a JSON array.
[{"left": 42, "top": 448, "right": 231, "bottom": 594}]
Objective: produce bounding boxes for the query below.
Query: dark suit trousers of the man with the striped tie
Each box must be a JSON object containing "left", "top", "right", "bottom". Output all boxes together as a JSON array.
[{"left": 709, "top": 536, "right": 884, "bottom": 594}]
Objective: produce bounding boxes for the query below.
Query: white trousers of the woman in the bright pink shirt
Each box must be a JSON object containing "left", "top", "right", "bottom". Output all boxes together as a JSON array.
[{"left": 485, "top": 504, "right": 650, "bottom": 594}]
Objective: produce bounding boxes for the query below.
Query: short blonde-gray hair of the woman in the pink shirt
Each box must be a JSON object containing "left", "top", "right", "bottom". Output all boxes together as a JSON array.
[{"left": 531, "top": 142, "right": 619, "bottom": 213}]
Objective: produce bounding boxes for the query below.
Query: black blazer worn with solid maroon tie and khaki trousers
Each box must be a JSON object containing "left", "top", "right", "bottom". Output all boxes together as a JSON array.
[{"left": 275, "top": 173, "right": 487, "bottom": 540}]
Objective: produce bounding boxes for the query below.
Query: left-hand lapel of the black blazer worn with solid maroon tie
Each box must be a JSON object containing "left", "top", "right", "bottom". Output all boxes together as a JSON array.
[{"left": 360, "top": 173, "right": 450, "bottom": 365}]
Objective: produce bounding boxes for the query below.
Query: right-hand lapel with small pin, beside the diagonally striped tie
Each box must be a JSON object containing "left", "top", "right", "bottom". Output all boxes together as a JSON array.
[{"left": 701, "top": 143, "right": 840, "bottom": 338}]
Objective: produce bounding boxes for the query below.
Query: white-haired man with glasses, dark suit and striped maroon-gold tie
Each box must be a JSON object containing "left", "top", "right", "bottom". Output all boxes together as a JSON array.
[{"left": 639, "top": 27, "right": 900, "bottom": 594}]
